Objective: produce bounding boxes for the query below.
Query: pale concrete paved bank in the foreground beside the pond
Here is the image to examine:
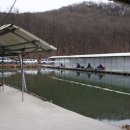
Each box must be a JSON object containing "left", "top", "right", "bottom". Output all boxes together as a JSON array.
[{"left": 0, "top": 86, "right": 121, "bottom": 130}]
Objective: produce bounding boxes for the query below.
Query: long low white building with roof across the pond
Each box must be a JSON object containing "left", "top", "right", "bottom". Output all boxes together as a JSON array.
[{"left": 50, "top": 53, "right": 130, "bottom": 72}]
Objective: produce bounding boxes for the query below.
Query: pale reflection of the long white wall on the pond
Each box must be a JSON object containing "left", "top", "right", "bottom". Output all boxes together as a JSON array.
[{"left": 44, "top": 69, "right": 130, "bottom": 92}]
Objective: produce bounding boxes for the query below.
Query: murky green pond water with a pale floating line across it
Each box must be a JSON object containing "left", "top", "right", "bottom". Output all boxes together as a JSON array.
[{"left": 1, "top": 68, "right": 130, "bottom": 126}]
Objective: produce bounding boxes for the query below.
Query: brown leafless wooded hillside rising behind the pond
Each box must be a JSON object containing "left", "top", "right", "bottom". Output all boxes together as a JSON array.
[{"left": 0, "top": 2, "right": 130, "bottom": 57}]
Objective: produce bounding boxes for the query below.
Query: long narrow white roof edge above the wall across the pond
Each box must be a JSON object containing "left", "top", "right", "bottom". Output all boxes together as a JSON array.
[{"left": 49, "top": 52, "right": 130, "bottom": 59}]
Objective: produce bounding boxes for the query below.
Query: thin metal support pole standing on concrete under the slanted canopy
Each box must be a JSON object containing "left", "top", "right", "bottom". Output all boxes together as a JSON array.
[{"left": 19, "top": 53, "right": 27, "bottom": 102}]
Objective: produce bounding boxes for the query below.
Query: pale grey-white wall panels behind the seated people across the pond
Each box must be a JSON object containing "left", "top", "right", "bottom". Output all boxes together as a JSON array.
[{"left": 55, "top": 56, "right": 130, "bottom": 72}]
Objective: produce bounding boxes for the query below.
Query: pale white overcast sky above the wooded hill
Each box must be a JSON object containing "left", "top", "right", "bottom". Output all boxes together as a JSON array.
[{"left": 0, "top": 0, "right": 108, "bottom": 12}]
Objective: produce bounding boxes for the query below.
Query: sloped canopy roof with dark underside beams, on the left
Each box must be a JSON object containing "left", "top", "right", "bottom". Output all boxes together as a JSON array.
[{"left": 0, "top": 24, "right": 56, "bottom": 56}]
